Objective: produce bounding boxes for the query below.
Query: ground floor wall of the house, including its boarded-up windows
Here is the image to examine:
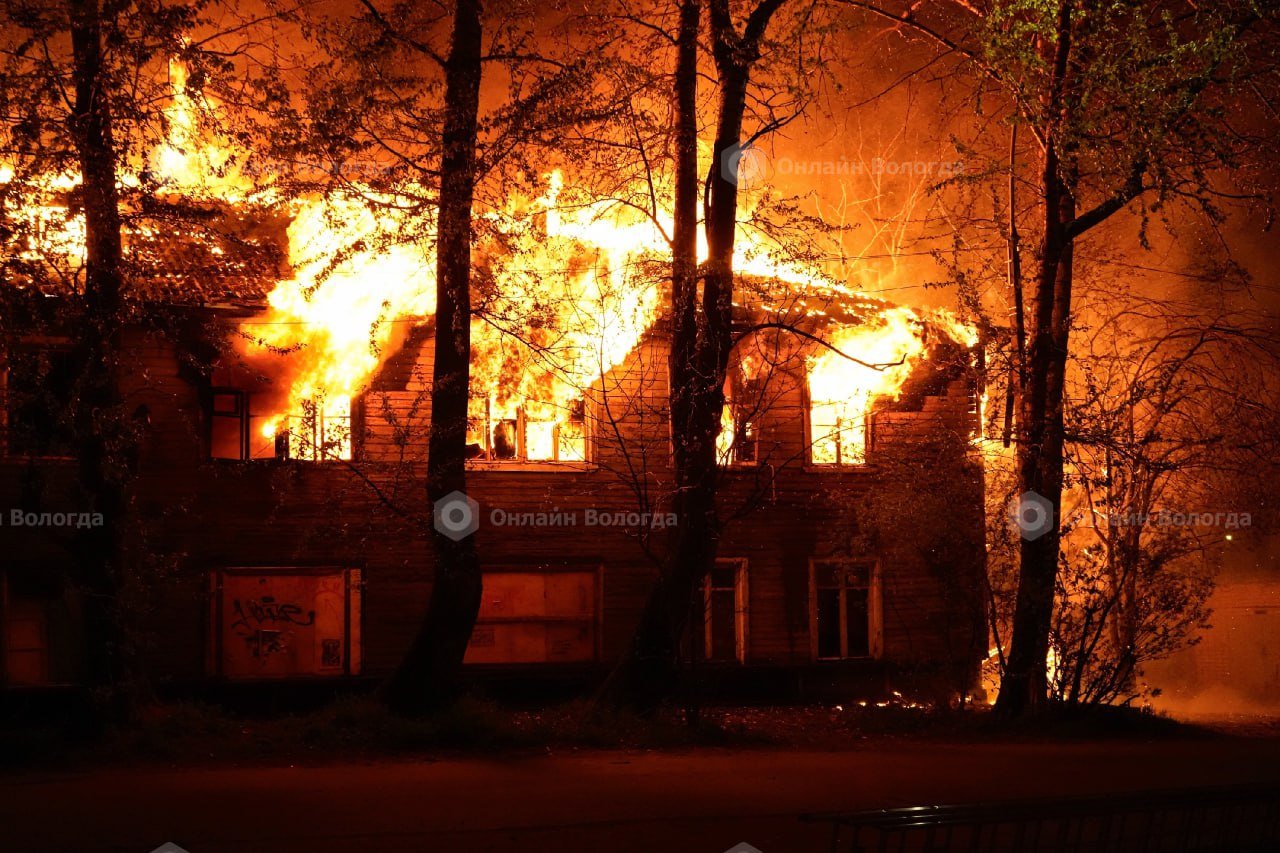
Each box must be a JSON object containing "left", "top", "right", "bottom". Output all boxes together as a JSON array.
[{"left": 0, "top": 462, "right": 984, "bottom": 697}]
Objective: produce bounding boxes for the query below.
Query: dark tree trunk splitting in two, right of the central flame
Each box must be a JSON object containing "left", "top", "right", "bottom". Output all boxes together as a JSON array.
[{"left": 605, "top": 0, "right": 783, "bottom": 713}]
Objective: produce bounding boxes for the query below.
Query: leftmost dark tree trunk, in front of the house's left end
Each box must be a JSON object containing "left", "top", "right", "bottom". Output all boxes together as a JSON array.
[{"left": 70, "top": 0, "right": 136, "bottom": 719}]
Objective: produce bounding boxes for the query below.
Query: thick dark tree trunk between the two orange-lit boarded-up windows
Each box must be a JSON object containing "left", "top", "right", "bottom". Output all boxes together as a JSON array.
[{"left": 384, "top": 0, "right": 483, "bottom": 715}]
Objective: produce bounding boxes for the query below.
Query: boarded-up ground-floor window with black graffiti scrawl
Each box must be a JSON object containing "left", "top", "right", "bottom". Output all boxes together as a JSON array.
[{"left": 210, "top": 569, "right": 361, "bottom": 679}]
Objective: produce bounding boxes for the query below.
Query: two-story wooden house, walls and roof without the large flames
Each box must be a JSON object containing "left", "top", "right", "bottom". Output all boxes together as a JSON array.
[{"left": 0, "top": 201, "right": 986, "bottom": 697}]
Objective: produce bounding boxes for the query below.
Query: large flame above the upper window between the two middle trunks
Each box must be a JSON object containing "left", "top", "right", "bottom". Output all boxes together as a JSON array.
[{"left": 471, "top": 174, "right": 662, "bottom": 461}]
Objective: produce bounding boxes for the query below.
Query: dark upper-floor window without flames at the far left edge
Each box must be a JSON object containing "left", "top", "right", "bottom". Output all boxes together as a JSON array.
[{"left": 0, "top": 343, "right": 76, "bottom": 457}]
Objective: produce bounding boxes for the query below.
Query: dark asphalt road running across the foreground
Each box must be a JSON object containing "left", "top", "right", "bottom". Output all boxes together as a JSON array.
[{"left": 0, "top": 739, "right": 1280, "bottom": 853}]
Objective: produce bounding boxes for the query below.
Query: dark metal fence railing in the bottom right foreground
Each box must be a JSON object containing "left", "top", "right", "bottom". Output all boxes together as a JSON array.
[{"left": 804, "top": 784, "right": 1280, "bottom": 853}]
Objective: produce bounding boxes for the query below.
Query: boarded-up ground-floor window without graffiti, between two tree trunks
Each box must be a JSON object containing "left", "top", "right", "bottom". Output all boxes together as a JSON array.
[{"left": 466, "top": 566, "right": 599, "bottom": 663}]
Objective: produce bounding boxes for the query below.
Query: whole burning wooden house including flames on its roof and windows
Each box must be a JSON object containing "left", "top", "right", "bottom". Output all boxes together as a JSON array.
[{"left": 0, "top": 166, "right": 986, "bottom": 695}]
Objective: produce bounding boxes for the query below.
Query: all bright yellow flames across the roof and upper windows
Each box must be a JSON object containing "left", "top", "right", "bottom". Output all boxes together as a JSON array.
[{"left": 0, "top": 63, "right": 975, "bottom": 464}]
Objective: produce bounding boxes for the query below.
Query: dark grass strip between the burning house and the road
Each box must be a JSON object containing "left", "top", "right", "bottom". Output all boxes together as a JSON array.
[{"left": 0, "top": 695, "right": 1233, "bottom": 768}]
